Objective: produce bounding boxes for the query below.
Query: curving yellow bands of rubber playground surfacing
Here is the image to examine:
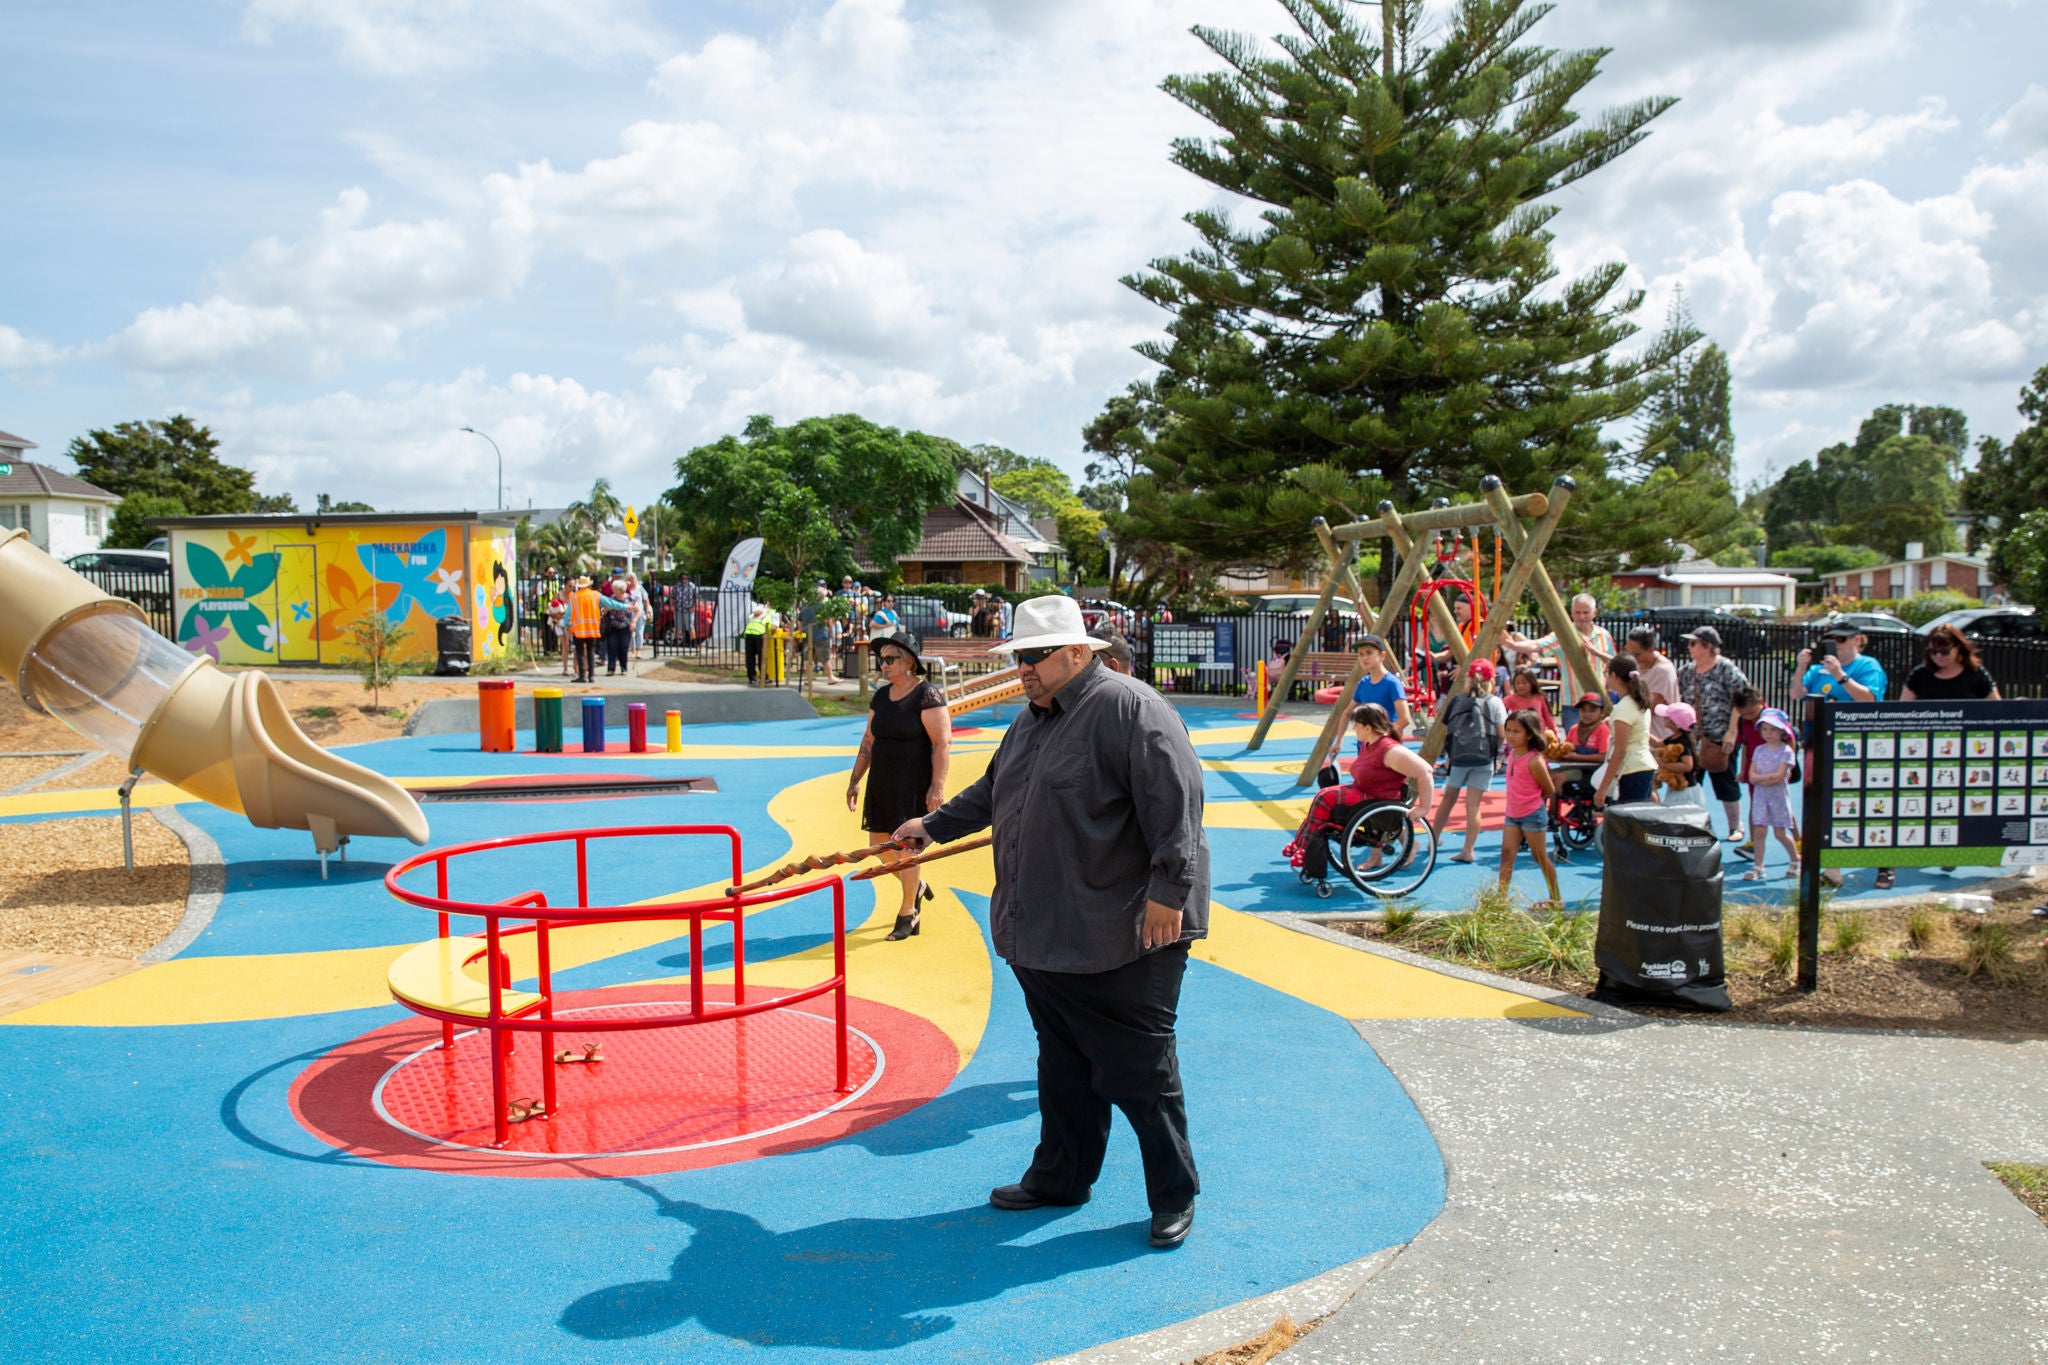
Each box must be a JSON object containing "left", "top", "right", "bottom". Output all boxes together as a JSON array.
[{"left": 0, "top": 726, "right": 1577, "bottom": 1023}]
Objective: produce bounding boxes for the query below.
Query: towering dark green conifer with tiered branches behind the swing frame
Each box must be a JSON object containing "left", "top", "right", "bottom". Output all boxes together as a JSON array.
[{"left": 1112, "top": 0, "right": 1690, "bottom": 577}]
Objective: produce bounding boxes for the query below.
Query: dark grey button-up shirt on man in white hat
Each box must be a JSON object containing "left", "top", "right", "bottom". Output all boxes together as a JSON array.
[{"left": 924, "top": 663, "right": 1208, "bottom": 972}]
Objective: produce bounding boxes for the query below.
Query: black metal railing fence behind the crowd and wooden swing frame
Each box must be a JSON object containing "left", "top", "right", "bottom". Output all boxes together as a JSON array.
[{"left": 1130, "top": 612, "right": 2048, "bottom": 708}]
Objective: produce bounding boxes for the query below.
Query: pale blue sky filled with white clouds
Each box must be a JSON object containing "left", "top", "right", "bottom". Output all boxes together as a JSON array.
[{"left": 0, "top": 0, "right": 2048, "bottom": 519}]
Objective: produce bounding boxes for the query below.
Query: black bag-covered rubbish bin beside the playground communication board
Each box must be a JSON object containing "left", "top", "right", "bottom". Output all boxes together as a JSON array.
[{"left": 1593, "top": 802, "right": 1729, "bottom": 1011}]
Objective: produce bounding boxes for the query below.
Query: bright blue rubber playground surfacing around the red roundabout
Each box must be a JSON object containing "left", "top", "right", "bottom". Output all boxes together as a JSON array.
[{"left": 0, "top": 718, "right": 1444, "bottom": 1365}]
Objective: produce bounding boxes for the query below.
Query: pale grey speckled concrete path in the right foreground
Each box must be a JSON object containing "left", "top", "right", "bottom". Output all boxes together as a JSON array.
[{"left": 1286, "top": 1017, "right": 2048, "bottom": 1365}]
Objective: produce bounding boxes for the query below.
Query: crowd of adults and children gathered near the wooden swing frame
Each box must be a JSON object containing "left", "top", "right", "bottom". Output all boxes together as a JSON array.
[{"left": 1276, "top": 609, "right": 1999, "bottom": 900}]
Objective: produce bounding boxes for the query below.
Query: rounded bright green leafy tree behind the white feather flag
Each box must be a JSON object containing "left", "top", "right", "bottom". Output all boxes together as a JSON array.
[{"left": 662, "top": 413, "right": 965, "bottom": 575}]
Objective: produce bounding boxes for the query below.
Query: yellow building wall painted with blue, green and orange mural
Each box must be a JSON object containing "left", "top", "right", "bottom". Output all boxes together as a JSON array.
[{"left": 170, "top": 522, "right": 518, "bottom": 665}]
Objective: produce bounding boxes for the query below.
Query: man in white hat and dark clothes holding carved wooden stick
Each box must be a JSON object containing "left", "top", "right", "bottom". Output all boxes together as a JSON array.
[{"left": 895, "top": 598, "right": 1208, "bottom": 1246}]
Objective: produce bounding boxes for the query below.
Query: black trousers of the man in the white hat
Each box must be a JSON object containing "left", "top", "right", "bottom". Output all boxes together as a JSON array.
[{"left": 1010, "top": 943, "right": 1202, "bottom": 1214}]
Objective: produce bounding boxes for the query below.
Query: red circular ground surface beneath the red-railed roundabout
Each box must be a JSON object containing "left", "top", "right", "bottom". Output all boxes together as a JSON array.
[{"left": 291, "top": 984, "right": 958, "bottom": 1177}]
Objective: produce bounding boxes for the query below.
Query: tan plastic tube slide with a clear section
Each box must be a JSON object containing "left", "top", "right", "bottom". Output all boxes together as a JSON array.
[{"left": 0, "top": 530, "right": 426, "bottom": 853}]
